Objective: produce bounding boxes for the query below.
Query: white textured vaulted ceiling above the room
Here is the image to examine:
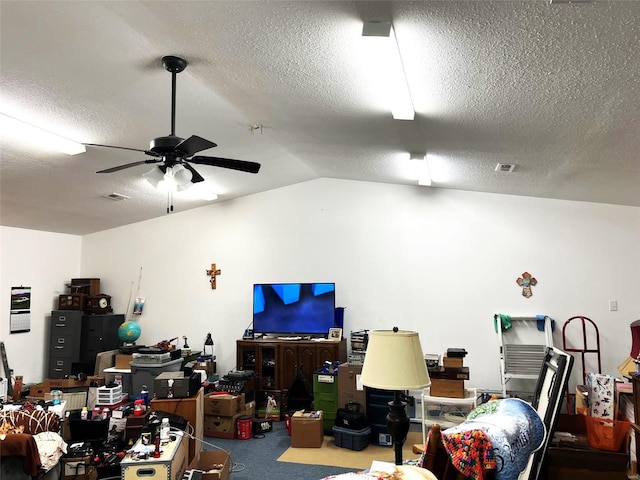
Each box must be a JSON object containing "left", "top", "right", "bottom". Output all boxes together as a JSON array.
[{"left": 0, "top": 0, "right": 640, "bottom": 234}]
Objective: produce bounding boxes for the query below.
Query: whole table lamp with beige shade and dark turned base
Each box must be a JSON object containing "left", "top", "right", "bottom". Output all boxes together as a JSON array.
[{"left": 360, "top": 327, "right": 431, "bottom": 465}]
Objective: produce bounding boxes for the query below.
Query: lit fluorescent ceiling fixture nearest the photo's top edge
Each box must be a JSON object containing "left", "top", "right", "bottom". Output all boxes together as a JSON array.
[{"left": 362, "top": 22, "right": 415, "bottom": 120}]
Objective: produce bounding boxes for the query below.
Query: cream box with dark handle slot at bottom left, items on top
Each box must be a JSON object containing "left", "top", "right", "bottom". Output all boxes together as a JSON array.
[{"left": 120, "top": 435, "right": 189, "bottom": 480}]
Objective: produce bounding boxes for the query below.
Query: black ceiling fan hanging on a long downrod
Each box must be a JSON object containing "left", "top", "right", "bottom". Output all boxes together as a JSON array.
[{"left": 84, "top": 55, "right": 260, "bottom": 209}]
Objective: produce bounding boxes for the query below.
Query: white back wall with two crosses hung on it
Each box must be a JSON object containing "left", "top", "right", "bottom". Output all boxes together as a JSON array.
[{"left": 79, "top": 179, "right": 640, "bottom": 389}]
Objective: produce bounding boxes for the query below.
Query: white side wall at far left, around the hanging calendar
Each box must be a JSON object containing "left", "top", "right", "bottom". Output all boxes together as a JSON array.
[{"left": 0, "top": 227, "right": 82, "bottom": 383}]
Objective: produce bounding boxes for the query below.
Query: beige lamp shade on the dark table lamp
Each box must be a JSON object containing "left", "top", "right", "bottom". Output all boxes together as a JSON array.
[{"left": 360, "top": 330, "right": 431, "bottom": 390}]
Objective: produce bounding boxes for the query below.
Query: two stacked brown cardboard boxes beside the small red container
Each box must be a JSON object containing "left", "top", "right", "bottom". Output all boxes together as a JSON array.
[{"left": 204, "top": 393, "right": 256, "bottom": 438}]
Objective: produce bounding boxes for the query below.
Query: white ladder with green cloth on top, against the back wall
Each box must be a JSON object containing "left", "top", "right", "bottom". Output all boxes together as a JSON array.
[{"left": 494, "top": 314, "right": 553, "bottom": 397}]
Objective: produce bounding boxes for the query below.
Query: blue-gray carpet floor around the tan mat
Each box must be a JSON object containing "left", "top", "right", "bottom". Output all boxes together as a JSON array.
[{"left": 203, "top": 422, "right": 355, "bottom": 480}]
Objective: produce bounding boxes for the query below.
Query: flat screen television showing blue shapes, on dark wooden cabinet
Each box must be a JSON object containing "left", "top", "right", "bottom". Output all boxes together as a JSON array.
[{"left": 253, "top": 283, "right": 336, "bottom": 337}]
